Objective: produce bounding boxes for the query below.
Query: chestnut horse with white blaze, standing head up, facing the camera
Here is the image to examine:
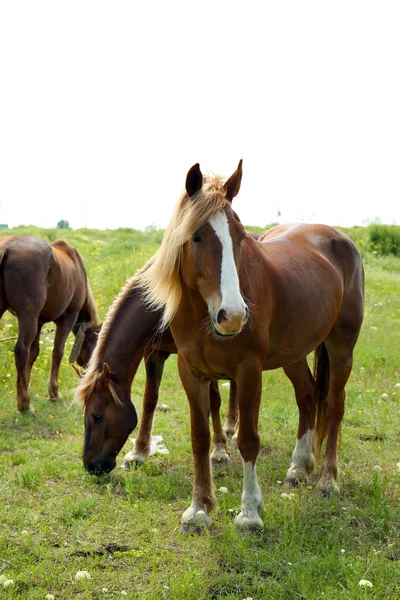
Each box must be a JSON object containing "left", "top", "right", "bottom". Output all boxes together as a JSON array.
[{"left": 136, "top": 161, "right": 364, "bottom": 530}]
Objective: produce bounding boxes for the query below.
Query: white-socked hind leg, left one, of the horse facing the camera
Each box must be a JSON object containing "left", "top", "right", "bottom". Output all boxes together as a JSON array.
[{"left": 284, "top": 358, "right": 317, "bottom": 488}]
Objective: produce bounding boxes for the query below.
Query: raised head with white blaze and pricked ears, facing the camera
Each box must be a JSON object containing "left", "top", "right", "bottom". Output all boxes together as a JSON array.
[{"left": 181, "top": 161, "right": 249, "bottom": 336}]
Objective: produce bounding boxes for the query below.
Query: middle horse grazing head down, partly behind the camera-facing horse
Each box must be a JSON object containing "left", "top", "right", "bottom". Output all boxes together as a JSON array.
[{"left": 75, "top": 270, "right": 234, "bottom": 474}]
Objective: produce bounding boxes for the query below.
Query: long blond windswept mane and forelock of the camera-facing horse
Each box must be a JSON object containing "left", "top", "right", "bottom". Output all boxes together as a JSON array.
[{"left": 135, "top": 175, "right": 228, "bottom": 331}]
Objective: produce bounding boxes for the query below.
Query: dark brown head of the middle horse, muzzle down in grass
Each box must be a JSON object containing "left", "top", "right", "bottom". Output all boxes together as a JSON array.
[{"left": 83, "top": 363, "right": 137, "bottom": 475}]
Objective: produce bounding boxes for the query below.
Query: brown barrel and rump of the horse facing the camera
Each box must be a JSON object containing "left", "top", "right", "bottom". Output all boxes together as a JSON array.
[{"left": 240, "top": 224, "right": 364, "bottom": 369}]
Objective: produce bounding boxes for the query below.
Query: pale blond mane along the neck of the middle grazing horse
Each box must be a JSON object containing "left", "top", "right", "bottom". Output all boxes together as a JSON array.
[{"left": 73, "top": 257, "right": 154, "bottom": 407}]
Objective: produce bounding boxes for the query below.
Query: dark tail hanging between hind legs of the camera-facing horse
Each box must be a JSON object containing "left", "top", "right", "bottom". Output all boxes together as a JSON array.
[{"left": 314, "top": 342, "right": 329, "bottom": 456}]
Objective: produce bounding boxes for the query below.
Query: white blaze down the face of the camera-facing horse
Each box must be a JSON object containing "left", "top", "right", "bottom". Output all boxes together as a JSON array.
[{"left": 208, "top": 211, "right": 246, "bottom": 315}]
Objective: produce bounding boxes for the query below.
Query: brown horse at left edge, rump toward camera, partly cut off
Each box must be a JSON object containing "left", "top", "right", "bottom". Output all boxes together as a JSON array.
[{"left": 0, "top": 236, "right": 100, "bottom": 413}]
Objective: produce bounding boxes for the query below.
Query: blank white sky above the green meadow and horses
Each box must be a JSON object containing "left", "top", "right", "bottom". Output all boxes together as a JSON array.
[{"left": 0, "top": 0, "right": 400, "bottom": 229}]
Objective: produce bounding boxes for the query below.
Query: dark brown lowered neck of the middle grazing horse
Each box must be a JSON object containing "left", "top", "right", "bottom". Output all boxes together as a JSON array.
[{"left": 99, "top": 290, "right": 161, "bottom": 386}]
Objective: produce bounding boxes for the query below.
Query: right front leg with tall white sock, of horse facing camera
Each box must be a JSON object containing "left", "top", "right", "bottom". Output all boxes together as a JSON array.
[{"left": 235, "top": 363, "right": 264, "bottom": 530}]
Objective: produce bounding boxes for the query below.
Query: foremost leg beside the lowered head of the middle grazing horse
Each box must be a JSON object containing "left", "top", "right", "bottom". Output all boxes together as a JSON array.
[{"left": 122, "top": 350, "right": 169, "bottom": 471}]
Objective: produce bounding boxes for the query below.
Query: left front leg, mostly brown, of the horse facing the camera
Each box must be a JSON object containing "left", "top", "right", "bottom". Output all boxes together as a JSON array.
[{"left": 178, "top": 355, "right": 216, "bottom": 532}]
